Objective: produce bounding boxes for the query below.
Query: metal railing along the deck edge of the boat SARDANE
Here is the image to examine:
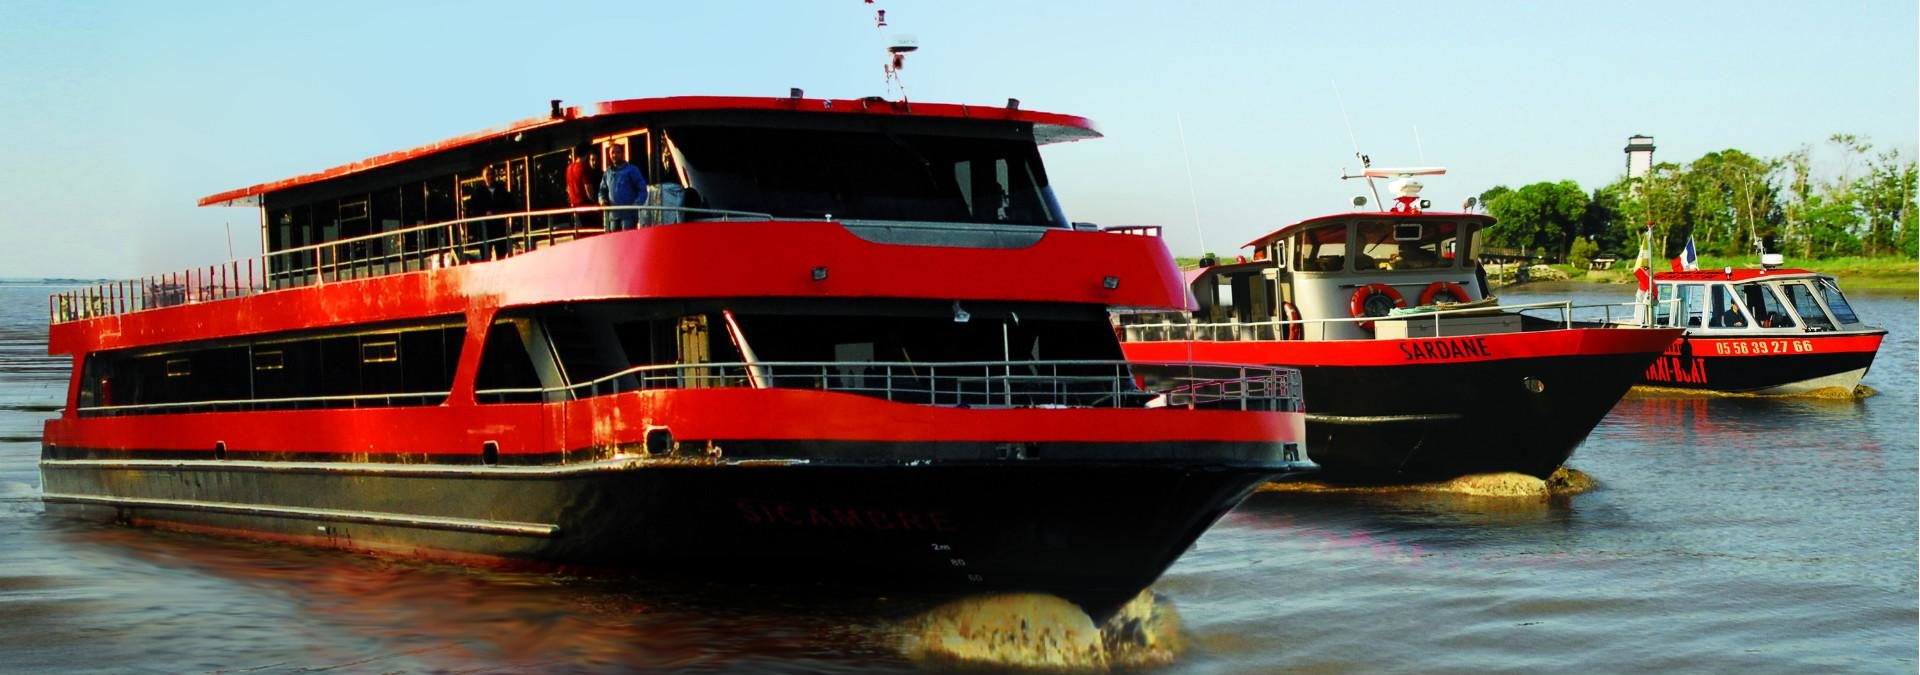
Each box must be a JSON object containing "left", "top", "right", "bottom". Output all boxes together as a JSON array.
[{"left": 1121, "top": 301, "right": 1670, "bottom": 341}]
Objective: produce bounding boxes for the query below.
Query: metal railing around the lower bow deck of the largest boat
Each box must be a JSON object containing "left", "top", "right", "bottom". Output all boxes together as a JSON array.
[{"left": 474, "top": 361, "right": 1302, "bottom": 412}]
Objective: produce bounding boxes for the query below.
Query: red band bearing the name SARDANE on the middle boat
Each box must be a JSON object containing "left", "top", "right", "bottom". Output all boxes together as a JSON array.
[{"left": 1121, "top": 328, "right": 1680, "bottom": 368}]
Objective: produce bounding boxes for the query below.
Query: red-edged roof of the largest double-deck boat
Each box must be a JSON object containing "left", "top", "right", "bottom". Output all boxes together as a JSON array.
[{"left": 200, "top": 96, "right": 1100, "bottom": 207}]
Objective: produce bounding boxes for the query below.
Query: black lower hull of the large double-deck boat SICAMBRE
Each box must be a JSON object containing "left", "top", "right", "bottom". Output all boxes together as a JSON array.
[{"left": 42, "top": 443, "right": 1300, "bottom": 617}]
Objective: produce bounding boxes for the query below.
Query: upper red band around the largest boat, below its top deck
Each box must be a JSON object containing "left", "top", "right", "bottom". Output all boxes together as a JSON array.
[{"left": 48, "top": 222, "right": 1187, "bottom": 355}]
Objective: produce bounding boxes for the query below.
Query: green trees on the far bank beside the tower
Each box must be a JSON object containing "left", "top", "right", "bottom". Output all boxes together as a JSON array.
[{"left": 1480, "top": 134, "right": 1920, "bottom": 261}]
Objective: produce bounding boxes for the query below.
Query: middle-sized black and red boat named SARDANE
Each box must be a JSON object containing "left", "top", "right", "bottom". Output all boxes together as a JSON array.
[{"left": 1116, "top": 169, "right": 1680, "bottom": 481}]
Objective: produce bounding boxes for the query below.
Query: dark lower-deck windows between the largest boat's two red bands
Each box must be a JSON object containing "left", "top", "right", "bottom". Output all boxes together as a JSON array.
[{"left": 79, "top": 301, "right": 1121, "bottom": 414}]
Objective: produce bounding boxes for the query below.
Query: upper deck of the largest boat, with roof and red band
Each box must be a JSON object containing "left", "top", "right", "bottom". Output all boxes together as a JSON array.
[{"left": 50, "top": 96, "right": 1185, "bottom": 349}]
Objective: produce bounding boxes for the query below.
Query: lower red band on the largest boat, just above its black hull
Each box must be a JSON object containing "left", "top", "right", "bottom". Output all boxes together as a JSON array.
[{"left": 46, "top": 389, "right": 1300, "bottom": 458}]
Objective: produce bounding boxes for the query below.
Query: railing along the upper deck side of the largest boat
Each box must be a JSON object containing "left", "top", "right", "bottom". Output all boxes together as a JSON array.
[{"left": 46, "top": 205, "right": 774, "bottom": 324}]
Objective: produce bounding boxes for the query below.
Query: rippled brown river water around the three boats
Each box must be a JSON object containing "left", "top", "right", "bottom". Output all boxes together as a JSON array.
[{"left": 0, "top": 284, "right": 1920, "bottom": 673}]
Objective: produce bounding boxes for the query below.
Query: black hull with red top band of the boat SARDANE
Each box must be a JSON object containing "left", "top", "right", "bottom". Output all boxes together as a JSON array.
[{"left": 1125, "top": 328, "right": 1678, "bottom": 481}]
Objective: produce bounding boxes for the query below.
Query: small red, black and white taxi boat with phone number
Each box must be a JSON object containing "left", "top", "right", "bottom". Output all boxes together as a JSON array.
[{"left": 1642, "top": 253, "right": 1887, "bottom": 395}]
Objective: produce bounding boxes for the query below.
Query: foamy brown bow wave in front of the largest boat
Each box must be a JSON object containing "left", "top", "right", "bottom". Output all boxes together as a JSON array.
[{"left": 902, "top": 591, "right": 1185, "bottom": 671}]
